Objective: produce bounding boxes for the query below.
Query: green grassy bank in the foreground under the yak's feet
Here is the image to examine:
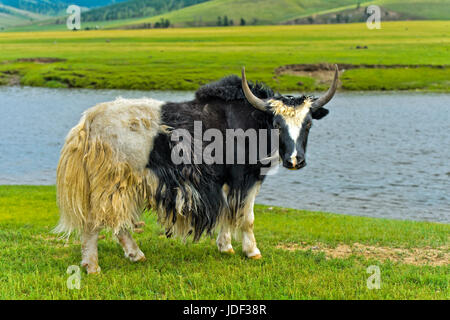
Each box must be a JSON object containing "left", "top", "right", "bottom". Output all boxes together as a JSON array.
[{"left": 0, "top": 186, "right": 450, "bottom": 299}]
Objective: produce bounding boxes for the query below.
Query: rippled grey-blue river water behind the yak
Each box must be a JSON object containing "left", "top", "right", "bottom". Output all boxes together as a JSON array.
[{"left": 0, "top": 87, "right": 450, "bottom": 223}]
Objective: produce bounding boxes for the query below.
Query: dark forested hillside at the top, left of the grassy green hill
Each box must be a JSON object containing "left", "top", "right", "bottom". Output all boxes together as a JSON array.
[{"left": 82, "top": 0, "right": 211, "bottom": 21}]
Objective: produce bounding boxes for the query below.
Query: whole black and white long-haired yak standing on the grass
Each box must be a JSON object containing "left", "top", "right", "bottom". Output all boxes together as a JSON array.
[{"left": 55, "top": 66, "right": 338, "bottom": 273}]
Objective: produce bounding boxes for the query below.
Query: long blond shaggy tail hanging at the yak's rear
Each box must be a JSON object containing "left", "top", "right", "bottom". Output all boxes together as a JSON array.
[{"left": 53, "top": 114, "right": 90, "bottom": 237}]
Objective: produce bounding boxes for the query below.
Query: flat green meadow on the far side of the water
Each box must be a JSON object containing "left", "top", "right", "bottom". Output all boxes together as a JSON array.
[{"left": 0, "top": 21, "right": 450, "bottom": 92}]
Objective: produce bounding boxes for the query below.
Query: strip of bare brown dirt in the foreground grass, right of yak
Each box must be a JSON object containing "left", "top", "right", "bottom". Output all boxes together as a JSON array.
[{"left": 276, "top": 243, "right": 450, "bottom": 266}]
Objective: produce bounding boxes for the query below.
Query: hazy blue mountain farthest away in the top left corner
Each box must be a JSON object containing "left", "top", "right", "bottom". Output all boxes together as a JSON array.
[{"left": 0, "top": 0, "right": 125, "bottom": 15}]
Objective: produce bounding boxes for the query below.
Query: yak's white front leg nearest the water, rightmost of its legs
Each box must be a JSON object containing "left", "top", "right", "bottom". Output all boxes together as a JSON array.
[{"left": 240, "top": 184, "right": 262, "bottom": 259}]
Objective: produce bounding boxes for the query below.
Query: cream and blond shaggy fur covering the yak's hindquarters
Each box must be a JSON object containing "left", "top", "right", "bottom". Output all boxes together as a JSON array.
[{"left": 55, "top": 99, "right": 162, "bottom": 235}]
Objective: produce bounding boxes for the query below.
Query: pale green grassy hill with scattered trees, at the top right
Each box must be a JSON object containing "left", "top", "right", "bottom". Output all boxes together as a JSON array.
[{"left": 119, "top": 0, "right": 450, "bottom": 27}]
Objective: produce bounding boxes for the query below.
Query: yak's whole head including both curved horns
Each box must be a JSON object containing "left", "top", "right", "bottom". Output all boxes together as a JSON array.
[{"left": 242, "top": 66, "right": 339, "bottom": 170}]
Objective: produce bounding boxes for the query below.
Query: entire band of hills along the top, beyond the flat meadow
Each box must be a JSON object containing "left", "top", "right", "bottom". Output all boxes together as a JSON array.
[{"left": 0, "top": 0, "right": 450, "bottom": 31}]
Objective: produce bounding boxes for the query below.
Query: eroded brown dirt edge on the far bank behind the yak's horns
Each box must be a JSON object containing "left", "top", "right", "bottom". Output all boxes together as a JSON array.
[{"left": 275, "top": 63, "right": 448, "bottom": 84}]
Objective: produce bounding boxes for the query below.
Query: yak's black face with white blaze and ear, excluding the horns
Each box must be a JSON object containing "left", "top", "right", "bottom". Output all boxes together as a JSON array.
[{"left": 268, "top": 96, "right": 328, "bottom": 170}]
